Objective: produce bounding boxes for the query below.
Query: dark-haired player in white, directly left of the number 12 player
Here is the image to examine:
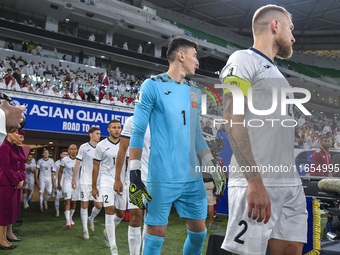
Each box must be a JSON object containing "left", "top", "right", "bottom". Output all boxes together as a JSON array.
[{"left": 72, "top": 127, "right": 103, "bottom": 239}]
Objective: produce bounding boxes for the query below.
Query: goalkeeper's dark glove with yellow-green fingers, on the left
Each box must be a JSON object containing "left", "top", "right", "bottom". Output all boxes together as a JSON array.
[{"left": 129, "top": 161, "right": 152, "bottom": 210}]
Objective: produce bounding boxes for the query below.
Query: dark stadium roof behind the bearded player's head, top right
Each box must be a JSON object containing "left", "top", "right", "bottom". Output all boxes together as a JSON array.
[{"left": 147, "top": 0, "right": 340, "bottom": 49}]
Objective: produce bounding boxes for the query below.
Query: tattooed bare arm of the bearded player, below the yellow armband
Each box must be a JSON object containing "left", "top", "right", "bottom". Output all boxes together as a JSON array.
[{"left": 223, "top": 93, "right": 271, "bottom": 223}]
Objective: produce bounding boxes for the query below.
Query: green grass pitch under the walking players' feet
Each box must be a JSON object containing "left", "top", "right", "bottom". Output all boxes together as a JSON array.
[{"left": 8, "top": 202, "right": 227, "bottom": 255}]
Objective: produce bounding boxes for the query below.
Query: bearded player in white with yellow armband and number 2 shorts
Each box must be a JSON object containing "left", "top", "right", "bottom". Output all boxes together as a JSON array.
[{"left": 220, "top": 5, "right": 308, "bottom": 255}]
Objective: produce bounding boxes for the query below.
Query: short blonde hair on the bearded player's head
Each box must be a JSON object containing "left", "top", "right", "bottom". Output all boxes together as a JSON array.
[{"left": 252, "top": 4, "right": 292, "bottom": 35}]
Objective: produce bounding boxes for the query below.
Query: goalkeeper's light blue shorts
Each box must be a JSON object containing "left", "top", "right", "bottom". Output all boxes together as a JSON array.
[{"left": 144, "top": 179, "right": 207, "bottom": 226}]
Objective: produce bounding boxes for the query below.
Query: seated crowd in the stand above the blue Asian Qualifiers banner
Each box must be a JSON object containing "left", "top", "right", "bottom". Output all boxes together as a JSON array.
[{"left": 0, "top": 55, "right": 149, "bottom": 107}]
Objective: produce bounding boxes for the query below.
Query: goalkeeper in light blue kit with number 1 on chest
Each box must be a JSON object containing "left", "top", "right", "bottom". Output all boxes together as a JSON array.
[{"left": 129, "top": 37, "right": 226, "bottom": 255}]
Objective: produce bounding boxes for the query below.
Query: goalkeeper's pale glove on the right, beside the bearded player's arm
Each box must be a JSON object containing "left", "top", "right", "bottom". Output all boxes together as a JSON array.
[{"left": 203, "top": 153, "right": 227, "bottom": 196}]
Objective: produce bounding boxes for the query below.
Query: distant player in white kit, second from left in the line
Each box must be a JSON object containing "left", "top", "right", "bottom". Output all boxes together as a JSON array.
[{"left": 35, "top": 149, "right": 54, "bottom": 212}]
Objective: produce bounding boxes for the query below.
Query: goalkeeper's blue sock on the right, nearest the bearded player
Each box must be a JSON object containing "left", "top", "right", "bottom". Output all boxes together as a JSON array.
[{"left": 183, "top": 230, "right": 207, "bottom": 255}]
